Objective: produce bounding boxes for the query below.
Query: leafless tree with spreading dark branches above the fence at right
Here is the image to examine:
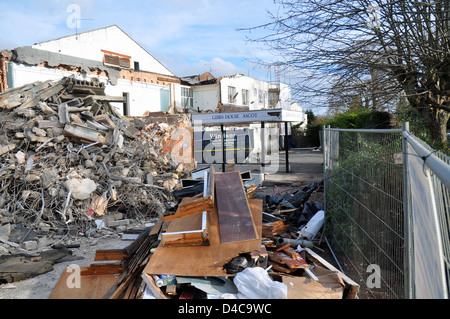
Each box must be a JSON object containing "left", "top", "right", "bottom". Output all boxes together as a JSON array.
[{"left": 242, "top": 0, "right": 450, "bottom": 141}]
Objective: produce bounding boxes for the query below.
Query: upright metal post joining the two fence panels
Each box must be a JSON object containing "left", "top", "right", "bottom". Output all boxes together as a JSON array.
[{"left": 402, "top": 122, "right": 414, "bottom": 299}]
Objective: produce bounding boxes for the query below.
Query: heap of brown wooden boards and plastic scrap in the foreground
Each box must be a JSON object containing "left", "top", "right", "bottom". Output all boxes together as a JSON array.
[{"left": 47, "top": 166, "right": 359, "bottom": 299}]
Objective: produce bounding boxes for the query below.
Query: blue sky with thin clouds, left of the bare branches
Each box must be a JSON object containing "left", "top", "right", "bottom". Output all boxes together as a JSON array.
[{"left": 0, "top": 0, "right": 289, "bottom": 84}]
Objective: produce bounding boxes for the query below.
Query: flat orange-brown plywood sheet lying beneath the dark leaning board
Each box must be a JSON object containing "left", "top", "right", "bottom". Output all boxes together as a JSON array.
[{"left": 144, "top": 199, "right": 262, "bottom": 277}]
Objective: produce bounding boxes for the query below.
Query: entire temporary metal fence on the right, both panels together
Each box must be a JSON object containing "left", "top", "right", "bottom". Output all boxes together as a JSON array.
[{"left": 322, "top": 126, "right": 450, "bottom": 299}]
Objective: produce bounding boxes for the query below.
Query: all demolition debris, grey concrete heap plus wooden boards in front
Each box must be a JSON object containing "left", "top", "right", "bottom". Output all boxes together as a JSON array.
[{"left": 0, "top": 78, "right": 359, "bottom": 299}]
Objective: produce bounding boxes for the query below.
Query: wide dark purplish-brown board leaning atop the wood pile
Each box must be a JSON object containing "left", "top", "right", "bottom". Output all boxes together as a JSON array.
[{"left": 215, "top": 172, "right": 257, "bottom": 243}]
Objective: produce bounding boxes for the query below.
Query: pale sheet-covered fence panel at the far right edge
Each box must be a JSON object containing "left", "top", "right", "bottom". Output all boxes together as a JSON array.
[{"left": 403, "top": 132, "right": 450, "bottom": 299}]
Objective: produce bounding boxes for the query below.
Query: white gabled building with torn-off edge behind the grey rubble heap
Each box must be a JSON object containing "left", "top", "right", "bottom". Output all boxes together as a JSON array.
[{"left": 0, "top": 25, "right": 182, "bottom": 116}]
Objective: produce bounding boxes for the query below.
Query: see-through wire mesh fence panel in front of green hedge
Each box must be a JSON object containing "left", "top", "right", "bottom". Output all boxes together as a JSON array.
[{"left": 324, "top": 129, "right": 404, "bottom": 298}]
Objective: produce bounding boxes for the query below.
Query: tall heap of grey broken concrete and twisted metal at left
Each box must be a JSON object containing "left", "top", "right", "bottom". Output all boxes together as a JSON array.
[{"left": 0, "top": 78, "right": 188, "bottom": 242}]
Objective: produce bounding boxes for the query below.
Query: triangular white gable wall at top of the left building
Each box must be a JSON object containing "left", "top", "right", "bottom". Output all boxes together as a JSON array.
[{"left": 32, "top": 25, "right": 174, "bottom": 76}]
